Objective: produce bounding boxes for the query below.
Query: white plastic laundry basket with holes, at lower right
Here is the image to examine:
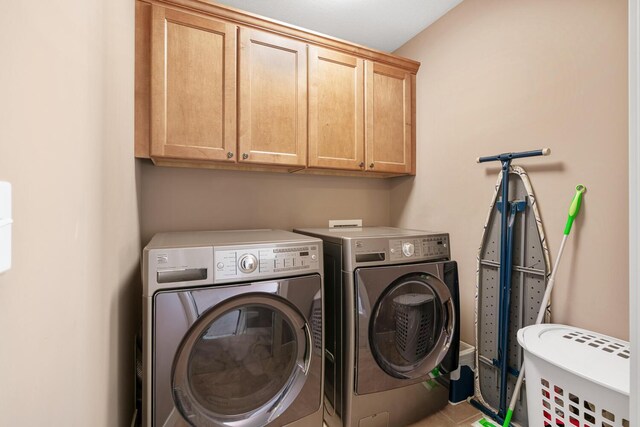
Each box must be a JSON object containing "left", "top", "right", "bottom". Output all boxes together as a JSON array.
[{"left": 518, "top": 324, "right": 630, "bottom": 427}]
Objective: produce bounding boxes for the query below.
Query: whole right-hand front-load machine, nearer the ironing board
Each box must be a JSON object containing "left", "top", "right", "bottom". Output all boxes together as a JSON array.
[{"left": 294, "top": 227, "right": 459, "bottom": 427}]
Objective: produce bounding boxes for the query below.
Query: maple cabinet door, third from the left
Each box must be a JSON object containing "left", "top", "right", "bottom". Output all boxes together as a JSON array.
[{"left": 309, "top": 46, "right": 364, "bottom": 170}]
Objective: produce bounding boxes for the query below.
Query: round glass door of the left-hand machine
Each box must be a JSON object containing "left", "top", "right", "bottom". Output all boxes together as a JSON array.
[{"left": 172, "top": 294, "right": 313, "bottom": 426}]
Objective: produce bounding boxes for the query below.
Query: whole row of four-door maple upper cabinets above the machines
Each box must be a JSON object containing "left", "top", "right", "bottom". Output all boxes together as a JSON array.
[{"left": 135, "top": 0, "right": 420, "bottom": 177}]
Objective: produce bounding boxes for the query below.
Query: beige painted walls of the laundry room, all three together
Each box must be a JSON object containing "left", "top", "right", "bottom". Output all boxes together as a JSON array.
[{"left": 0, "top": 0, "right": 628, "bottom": 426}]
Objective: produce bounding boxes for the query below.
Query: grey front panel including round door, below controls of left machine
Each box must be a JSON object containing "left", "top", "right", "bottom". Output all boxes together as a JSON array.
[{"left": 153, "top": 274, "right": 322, "bottom": 427}]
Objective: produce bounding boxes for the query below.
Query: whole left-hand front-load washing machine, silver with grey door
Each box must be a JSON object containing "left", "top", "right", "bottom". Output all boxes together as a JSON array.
[{"left": 143, "top": 230, "right": 323, "bottom": 427}]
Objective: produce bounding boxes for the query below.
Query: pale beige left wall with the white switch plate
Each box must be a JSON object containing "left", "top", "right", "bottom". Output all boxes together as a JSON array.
[{"left": 0, "top": 0, "right": 140, "bottom": 427}]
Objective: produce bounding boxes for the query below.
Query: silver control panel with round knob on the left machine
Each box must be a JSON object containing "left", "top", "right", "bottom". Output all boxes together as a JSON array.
[{"left": 213, "top": 243, "right": 321, "bottom": 283}]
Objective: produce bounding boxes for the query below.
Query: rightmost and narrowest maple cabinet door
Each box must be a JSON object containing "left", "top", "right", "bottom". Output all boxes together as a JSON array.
[{"left": 365, "top": 61, "right": 413, "bottom": 173}]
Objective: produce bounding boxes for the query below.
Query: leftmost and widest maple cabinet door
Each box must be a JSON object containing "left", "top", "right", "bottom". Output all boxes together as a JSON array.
[{"left": 151, "top": 5, "right": 237, "bottom": 161}]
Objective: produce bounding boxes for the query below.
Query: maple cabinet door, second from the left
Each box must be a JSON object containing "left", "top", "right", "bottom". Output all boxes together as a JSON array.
[{"left": 239, "top": 28, "right": 307, "bottom": 166}]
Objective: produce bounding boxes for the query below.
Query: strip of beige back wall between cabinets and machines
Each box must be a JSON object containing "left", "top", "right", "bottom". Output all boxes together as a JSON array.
[{"left": 140, "top": 162, "right": 391, "bottom": 245}]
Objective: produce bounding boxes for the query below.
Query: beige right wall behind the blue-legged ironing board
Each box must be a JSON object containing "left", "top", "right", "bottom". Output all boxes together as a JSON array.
[{"left": 391, "top": 0, "right": 629, "bottom": 342}]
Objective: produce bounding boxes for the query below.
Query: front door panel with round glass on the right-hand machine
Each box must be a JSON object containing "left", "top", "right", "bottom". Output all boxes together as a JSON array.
[{"left": 356, "top": 263, "right": 455, "bottom": 394}]
